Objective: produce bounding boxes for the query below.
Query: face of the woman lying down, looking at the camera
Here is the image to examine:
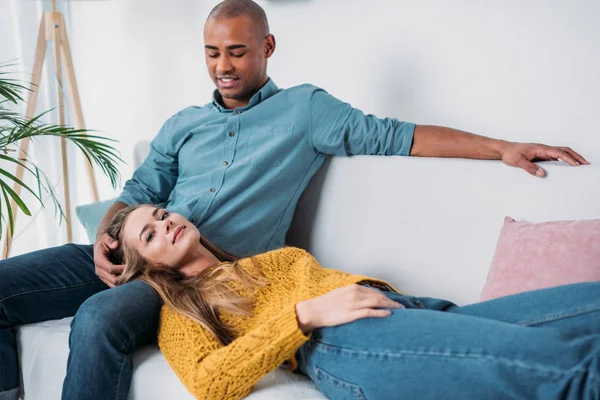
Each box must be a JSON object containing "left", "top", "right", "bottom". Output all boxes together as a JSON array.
[{"left": 123, "top": 206, "right": 202, "bottom": 268}]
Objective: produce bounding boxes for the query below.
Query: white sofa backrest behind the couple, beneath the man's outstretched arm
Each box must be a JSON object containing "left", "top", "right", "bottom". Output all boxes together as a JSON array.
[{"left": 135, "top": 142, "right": 600, "bottom": 304}]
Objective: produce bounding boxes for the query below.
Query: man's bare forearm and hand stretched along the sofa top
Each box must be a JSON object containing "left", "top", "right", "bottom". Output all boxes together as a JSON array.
[{"left": 410, "top": 125, "right": 589, "bottom": 177}]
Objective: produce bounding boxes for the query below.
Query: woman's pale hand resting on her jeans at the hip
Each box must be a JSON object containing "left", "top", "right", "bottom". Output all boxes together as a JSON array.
[{"left": 296, "top": 284, "right": 404, "bottom": 334}]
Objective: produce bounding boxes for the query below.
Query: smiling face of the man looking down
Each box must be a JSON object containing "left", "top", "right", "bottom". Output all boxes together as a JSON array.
[{"left": 204, "top": 16, "right": 275, "bottom": 108}]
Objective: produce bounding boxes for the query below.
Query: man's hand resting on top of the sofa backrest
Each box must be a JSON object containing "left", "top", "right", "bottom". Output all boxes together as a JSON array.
[{"left": 502, "top": 142, "right": 589, "bottom": 177}]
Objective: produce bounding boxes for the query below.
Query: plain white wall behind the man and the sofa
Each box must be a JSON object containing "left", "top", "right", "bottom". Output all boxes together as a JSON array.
[{"left": 0, "top": 0, "right": 600, "bottom": 253}]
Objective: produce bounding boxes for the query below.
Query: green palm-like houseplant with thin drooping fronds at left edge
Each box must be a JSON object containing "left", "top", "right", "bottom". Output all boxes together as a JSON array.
[{"left": 0, "top": 63, "right": 122, "bottom": 235}]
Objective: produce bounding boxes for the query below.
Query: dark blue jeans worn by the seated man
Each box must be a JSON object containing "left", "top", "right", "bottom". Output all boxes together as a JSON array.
[{"left": 0, "top": 244, "right": 161, "bottom": 400}]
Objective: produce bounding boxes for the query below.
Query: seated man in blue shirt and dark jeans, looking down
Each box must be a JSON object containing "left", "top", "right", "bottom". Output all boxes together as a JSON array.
[{"left": 0, "top": 0, "right": 587, "bottom": 400}]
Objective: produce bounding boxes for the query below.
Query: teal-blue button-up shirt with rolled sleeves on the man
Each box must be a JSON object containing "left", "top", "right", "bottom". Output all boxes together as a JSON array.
[{"left": 117, "top": 79, "right": 415, "bottom": 256}]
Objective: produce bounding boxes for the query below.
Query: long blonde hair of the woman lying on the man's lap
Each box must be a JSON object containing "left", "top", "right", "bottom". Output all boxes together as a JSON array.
[{"left": 106, "top": 205, "right": 266, "bottom": 345}]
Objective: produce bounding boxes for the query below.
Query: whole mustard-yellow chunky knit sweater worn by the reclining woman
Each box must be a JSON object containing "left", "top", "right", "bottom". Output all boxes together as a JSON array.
[{"left": 158, "top": 247, "right": 396, "bottom": 400}]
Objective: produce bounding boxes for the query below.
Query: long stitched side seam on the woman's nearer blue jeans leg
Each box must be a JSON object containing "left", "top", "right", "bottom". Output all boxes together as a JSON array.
[{"left": 315, "top": 340, "right": 587, "bottom": 376}]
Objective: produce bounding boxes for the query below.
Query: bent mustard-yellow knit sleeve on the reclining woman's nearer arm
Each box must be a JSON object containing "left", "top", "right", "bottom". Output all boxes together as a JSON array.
[{"left": 158, "top": 305, "right": 309, "bottom": 400}]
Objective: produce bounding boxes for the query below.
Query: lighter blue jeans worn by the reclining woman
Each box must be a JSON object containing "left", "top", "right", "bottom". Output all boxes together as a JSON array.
[{"left": 297, "top": 282, "right": 600, "bottom": 400}]
